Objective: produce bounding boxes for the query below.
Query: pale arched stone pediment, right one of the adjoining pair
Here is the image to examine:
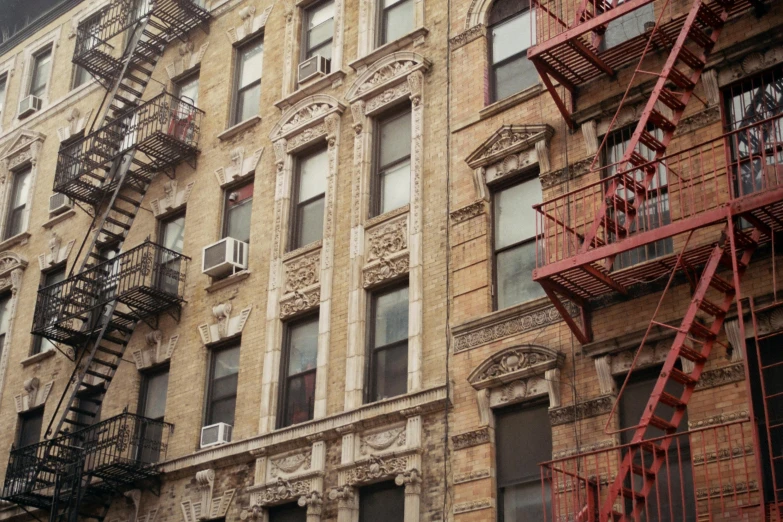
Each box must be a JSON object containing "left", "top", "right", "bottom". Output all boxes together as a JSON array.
[{"left": 345, "top": 51, "right": 431, "bottom": 104}]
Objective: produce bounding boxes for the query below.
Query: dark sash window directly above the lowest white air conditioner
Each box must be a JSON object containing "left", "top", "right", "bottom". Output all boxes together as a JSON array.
[{"left": 205, "top": 345, "right": 239, "bottom": 426}]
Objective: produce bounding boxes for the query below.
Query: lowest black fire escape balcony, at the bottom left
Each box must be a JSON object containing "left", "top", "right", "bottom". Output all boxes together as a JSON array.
[{"left": 1, "top": 413, "right": 173, "bottom": 508}]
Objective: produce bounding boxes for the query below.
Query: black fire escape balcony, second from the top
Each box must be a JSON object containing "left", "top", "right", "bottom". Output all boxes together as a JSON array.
[{"left": 54, "top": 92, "right": 204, "bottom": 204}]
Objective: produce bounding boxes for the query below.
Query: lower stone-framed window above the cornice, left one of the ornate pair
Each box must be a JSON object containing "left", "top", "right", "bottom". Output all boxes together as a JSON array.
[{"left": 278, "top": 315, "right": 318, "bottom": 428}]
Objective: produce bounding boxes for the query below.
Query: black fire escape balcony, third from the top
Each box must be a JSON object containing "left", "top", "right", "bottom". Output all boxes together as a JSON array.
[{"left": 32, "top": 241, "right": 190, "bottom": 346}]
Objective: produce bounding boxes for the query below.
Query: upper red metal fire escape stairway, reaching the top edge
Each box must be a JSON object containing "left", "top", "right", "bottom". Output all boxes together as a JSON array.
[{"left": 580, "top": 0, "right": 733, "bottom": 269}]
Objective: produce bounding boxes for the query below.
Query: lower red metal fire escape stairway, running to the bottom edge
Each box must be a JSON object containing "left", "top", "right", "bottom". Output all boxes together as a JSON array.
[{"left": 600, "top": 221, "right": 761, "bottom": 522}]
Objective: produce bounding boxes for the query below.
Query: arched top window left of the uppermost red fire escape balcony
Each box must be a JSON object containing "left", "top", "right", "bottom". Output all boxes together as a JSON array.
[{"left": 489, "top": 0, "right": 538, "bottom": 102}]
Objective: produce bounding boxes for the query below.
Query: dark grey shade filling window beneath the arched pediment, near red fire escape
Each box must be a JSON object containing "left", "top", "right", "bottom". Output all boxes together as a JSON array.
[{"left": 495, "top": 403, "right": 552, "bottom": 488}]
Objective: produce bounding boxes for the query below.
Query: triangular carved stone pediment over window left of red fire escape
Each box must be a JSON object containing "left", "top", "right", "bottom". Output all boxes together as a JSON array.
[{"left": 465, "top": 124, "right": 555, "bottom": 169}]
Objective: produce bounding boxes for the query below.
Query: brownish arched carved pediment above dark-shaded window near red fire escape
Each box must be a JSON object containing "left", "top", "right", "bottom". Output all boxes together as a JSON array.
[{"left": 468, "top": 345, "right": 565, "bottom": 390}]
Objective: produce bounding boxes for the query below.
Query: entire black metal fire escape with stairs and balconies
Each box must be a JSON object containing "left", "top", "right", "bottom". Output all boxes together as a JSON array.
[{"left": 0, "top": 0, "right": 210, "bottom": 522}]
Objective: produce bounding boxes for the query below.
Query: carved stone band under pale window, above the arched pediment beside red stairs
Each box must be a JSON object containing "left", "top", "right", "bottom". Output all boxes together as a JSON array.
[{"left": 454, "top": 301, "right": 578, "bottom": 353}]
